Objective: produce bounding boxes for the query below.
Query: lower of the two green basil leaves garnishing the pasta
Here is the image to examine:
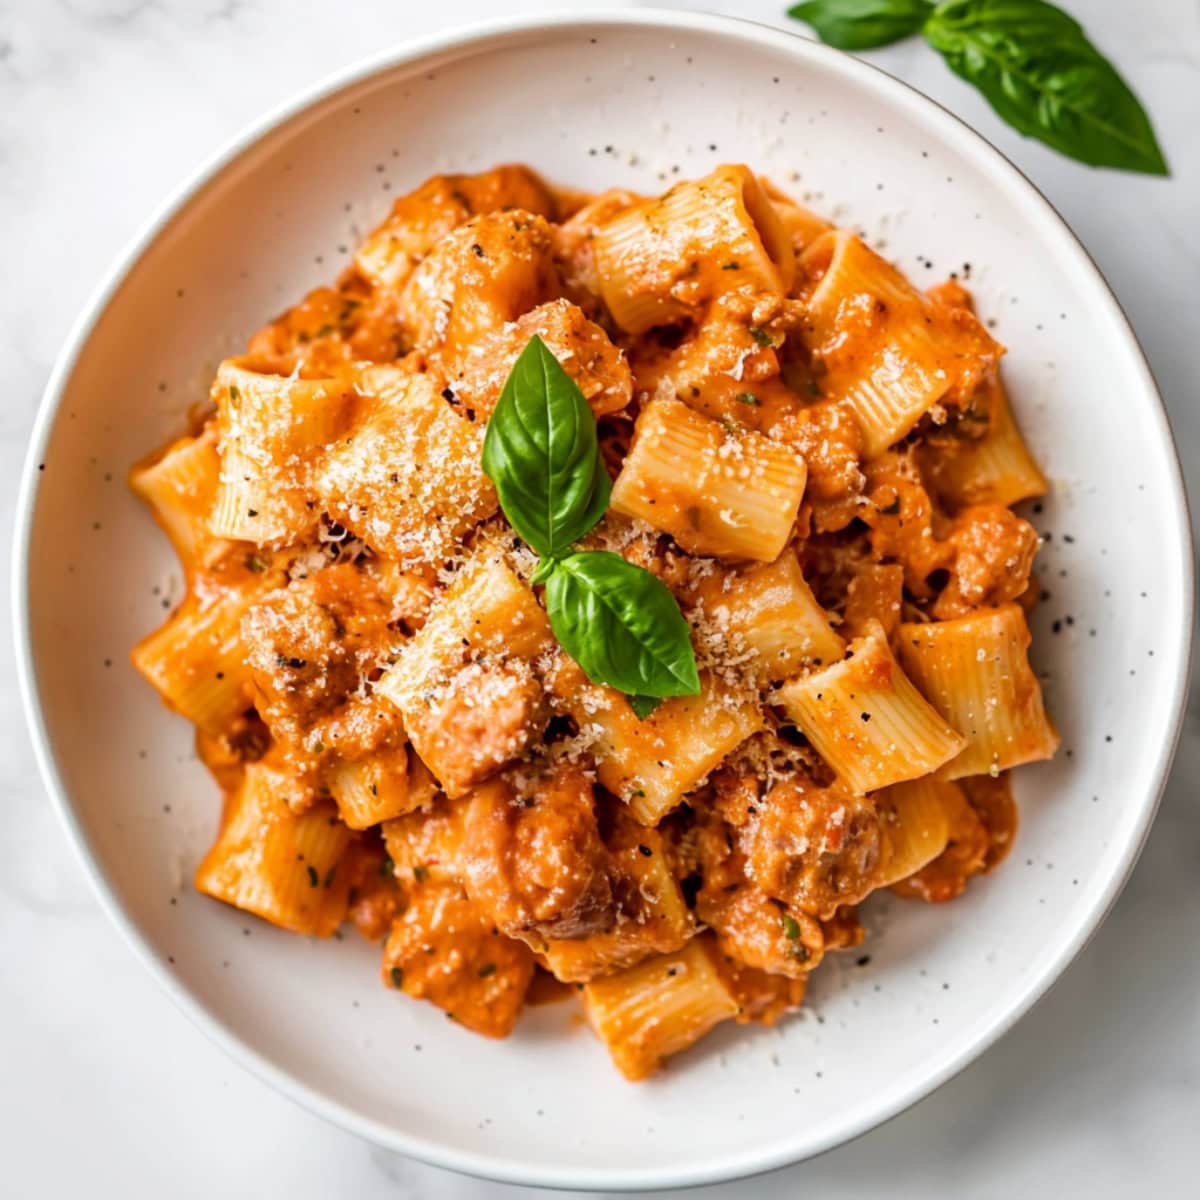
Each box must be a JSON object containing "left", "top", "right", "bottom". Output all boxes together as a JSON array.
[{"left": 546, "top": 550, "right": 700, "bottom": 712}]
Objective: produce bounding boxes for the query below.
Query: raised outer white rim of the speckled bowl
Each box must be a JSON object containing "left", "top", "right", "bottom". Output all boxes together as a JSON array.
[{"left": 12, "top": 8, "right": 1195, "bottom": 1192}]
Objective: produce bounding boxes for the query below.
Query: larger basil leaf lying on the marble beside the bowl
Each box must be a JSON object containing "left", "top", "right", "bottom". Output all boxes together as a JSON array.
[{"left": 924, "top": 0, "right": 1169, "bottom": 175}]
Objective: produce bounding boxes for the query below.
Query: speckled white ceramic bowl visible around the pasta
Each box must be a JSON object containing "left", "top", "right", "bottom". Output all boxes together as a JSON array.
[{"left": 16, "top": 12, "right": 1192, "bottom": 1189}]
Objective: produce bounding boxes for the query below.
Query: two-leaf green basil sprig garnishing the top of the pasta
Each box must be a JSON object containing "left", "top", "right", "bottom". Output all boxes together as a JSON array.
[{"left": 484, "top": 336, "right": 700, "bottom": 718}]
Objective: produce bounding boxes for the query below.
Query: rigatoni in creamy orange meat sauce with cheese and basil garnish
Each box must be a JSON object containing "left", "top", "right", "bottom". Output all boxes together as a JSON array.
[{"left": 131, "top": 166, "right": 1057, "bottom": 1079}]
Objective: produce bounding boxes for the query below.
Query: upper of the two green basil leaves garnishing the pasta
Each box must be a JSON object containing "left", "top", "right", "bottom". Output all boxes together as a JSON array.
[{"left": 484, "top": 335, "right": 612, "bottom": 558}]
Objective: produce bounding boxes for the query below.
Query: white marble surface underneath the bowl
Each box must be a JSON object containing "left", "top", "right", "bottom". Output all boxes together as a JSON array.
[{"left": 0, "top": 0, "right": 1200, "bottom": 1200}]
